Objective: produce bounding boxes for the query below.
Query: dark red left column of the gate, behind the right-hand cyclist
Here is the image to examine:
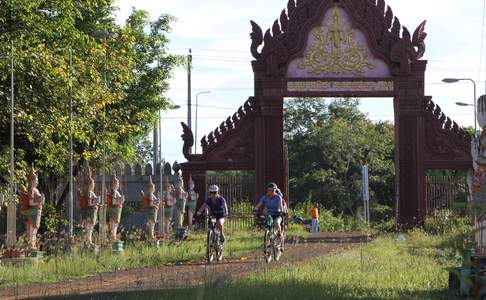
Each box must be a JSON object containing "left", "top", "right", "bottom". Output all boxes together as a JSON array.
[{"left": 255, "top": 97, "right": 287, "bottom": 204}]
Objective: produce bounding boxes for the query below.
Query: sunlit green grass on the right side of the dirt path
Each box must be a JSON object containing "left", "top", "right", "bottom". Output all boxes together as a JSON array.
[{"left": 143, "top": 231, "right": 459, "bottom": 300}]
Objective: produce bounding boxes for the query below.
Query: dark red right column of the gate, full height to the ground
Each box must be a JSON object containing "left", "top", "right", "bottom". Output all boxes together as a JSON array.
[{"left": 394, "top": 62, "right": 426, "bottom": 229}]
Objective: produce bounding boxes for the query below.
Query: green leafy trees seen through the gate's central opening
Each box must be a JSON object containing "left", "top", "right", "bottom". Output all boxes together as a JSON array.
[{"left": 284, "top": 99, "right": 394, "bottom": 214}]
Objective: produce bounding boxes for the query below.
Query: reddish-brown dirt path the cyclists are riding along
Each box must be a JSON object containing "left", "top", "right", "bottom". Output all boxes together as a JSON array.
[{"left": 0, "top": 233, "right": 367, "bottom": 299}]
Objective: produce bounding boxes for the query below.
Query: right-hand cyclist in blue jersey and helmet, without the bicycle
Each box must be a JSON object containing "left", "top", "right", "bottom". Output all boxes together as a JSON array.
[{"left": 253, "top": 182, "right": 284, "bottom": 244}]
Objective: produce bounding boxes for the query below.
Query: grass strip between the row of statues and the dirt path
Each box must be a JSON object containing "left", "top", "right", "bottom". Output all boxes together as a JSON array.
[{"left": 0, "top": 230, "right": 270, "bottom": 288}]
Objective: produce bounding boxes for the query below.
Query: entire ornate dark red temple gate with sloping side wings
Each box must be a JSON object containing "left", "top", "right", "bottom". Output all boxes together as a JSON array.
[{"left": 181, "top": 0, "right": 471, "bottom": 228}]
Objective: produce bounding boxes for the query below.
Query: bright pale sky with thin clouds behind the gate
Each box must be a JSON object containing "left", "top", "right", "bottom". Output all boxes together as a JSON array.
[{"left": 116, "top": 0, "right": 486, "bottom": 162}]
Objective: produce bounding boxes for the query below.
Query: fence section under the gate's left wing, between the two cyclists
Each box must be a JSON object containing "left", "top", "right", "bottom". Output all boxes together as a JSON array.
[{"left": 206, "top": 173, "right": 255, "bottom": 229}]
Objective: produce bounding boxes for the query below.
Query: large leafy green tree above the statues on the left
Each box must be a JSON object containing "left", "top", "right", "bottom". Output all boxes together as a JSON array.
[{"left": 0, "top": 0, "right": 180, "bottom": 206}]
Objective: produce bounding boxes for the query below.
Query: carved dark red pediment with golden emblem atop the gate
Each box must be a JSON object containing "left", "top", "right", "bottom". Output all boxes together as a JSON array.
[{"left": 251, "top": 0, "right": 427, "bottom": 78}]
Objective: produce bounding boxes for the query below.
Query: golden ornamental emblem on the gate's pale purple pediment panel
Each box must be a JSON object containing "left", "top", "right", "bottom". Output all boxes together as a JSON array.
[{"left": 298, "top": 8, "right": 375, "bottom": 74}]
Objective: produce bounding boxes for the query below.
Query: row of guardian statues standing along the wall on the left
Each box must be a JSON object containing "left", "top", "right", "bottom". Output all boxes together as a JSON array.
[{"left": 0, "top": 166, "right": 199, "bottom": 251}]
